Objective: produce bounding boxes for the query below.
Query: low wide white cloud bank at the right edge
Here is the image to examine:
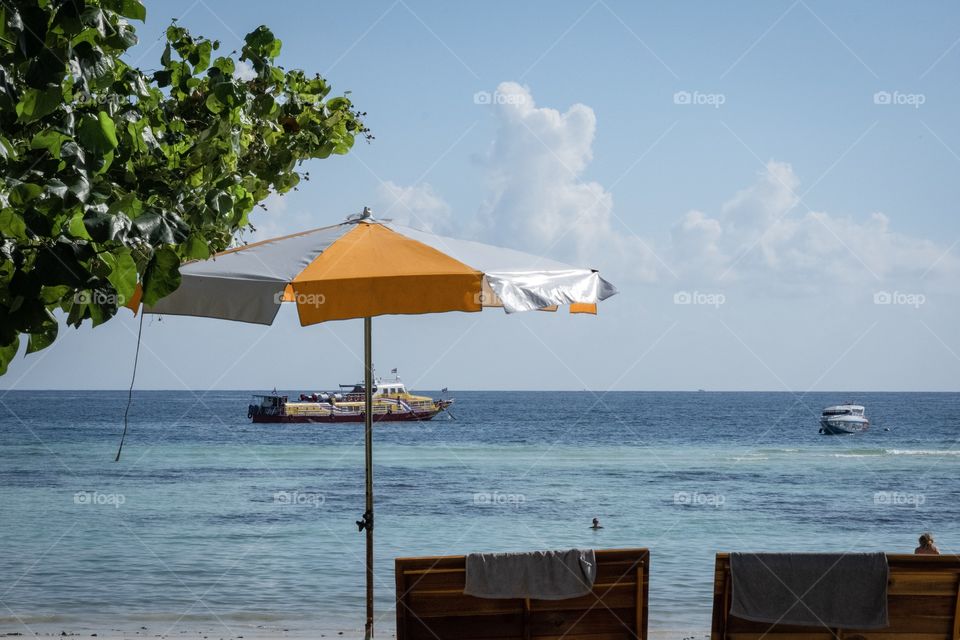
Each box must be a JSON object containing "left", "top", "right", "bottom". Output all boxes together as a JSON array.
[{"left": 669, "top": 161, "right": 960, "bottom": 291}]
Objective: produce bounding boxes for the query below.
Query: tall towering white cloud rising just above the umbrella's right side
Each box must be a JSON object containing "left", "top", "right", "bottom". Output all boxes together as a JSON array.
[{"left": 479, "top": 82, "right": 654, "bottom": 278}]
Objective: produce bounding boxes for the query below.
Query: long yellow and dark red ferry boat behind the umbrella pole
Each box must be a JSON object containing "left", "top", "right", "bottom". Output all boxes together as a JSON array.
[{"left": 247, "top": 378, "right": 453, "bottom": 423}]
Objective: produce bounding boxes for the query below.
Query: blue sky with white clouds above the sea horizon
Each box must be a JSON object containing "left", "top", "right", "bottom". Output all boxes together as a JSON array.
[{"left": 0, "top": 0, "right": 960, "bottom": 393}]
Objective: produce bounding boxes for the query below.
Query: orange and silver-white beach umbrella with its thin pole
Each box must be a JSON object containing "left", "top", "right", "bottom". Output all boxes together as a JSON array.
[{"left": 135, "top": 208, "right": 617, "bottom": 638}]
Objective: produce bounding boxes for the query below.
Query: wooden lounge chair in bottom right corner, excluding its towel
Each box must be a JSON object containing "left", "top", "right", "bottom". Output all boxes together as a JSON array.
[{"left": 710, "top": 553, "right": 960, "bottom": 640}]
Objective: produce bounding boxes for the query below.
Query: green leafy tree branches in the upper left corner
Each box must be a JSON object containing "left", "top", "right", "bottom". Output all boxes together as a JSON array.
[{"left": 0, "top": 0, "right": 369, "bottom": 374}]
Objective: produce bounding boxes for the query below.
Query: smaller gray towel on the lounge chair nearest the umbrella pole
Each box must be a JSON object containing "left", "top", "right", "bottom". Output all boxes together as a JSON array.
[{"left": 463, "top": 549, "right": 597, "bottom": 600}]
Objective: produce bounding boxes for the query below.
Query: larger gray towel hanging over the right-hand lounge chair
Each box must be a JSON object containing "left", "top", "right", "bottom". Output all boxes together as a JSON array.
[{"left": 730, "top": 553, "right": 888, "bottom": 629}]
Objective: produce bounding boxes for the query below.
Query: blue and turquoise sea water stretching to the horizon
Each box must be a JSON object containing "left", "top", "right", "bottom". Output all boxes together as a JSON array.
[{"left": 0, "top": 391, "right": 960, "bottom": 637}]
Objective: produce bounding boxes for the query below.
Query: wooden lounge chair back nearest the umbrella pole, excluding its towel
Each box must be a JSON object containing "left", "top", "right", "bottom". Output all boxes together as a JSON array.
[{"left": 396, "top": 549, "right": 650, "bottom": 640}]
